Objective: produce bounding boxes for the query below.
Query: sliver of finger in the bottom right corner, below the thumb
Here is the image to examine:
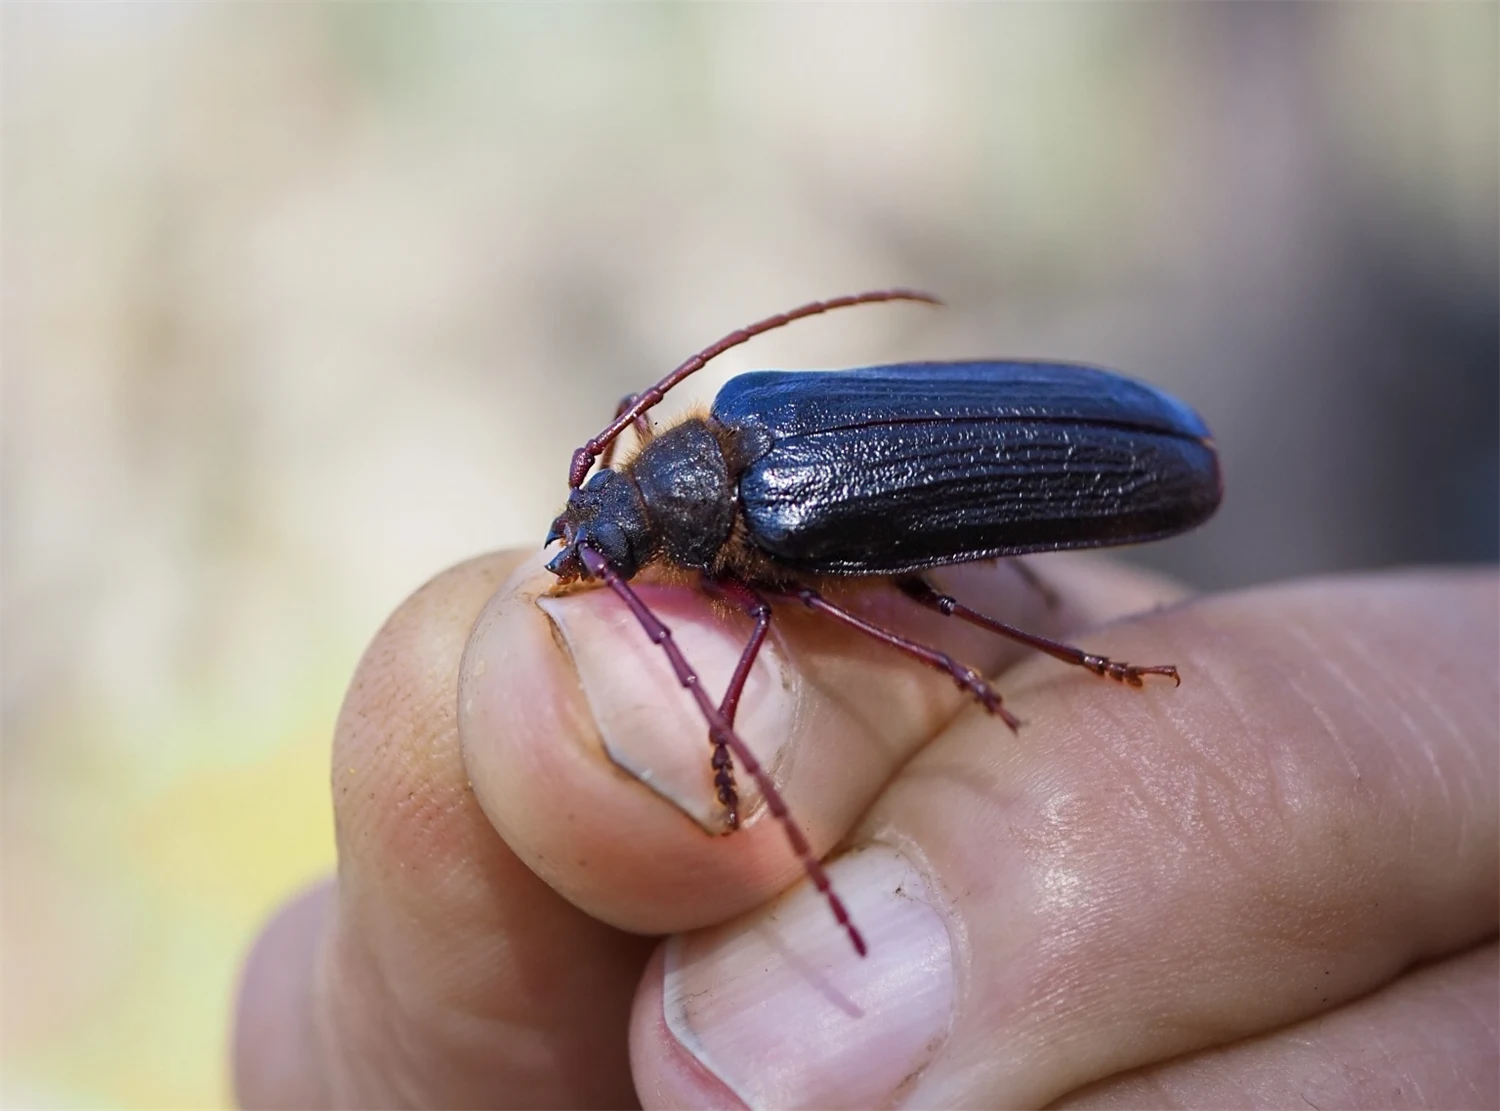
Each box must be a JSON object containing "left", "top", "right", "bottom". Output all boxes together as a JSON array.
[{"left": 1053, "top": 942, "right": 1500, "bottom": 1111}]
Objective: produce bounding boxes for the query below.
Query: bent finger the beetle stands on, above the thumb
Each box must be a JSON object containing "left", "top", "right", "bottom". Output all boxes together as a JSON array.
[{"left": 461, "top": 556, "right": 1181, "bottom": 933}]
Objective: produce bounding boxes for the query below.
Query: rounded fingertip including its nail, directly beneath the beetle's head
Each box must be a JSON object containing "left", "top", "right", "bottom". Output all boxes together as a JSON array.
[{"left": 459, "top": 561, "right": 795, "bottom": 933}]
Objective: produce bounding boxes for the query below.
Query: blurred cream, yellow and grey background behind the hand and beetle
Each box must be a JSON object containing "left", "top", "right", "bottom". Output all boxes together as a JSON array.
[{"left": 0, "top": 0, "right": 1500, "bottom": 1108}]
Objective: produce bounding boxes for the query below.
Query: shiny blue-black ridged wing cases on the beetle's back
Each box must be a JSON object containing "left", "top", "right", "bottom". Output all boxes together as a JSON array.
[{"left": 713, "top": 361, "right": 1221, "bottom": 574}]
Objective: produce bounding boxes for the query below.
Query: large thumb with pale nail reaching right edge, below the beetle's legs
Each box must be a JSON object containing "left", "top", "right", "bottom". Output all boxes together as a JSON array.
[{"left": 633, "top": 573, "right": 1500, "bottom": 1108}]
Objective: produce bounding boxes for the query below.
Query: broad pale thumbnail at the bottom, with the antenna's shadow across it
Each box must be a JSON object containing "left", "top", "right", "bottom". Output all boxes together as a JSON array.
[{"left": 662, "top": 846, "right": 954, "bottom": 1108}]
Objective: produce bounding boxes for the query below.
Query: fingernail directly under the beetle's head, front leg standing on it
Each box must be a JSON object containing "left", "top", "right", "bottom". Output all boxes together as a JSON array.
[{"left": 537, "top": 583, "right": 797, "bottom": 834}]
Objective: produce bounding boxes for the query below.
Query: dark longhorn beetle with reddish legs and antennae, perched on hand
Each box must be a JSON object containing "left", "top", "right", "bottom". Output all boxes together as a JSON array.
[{"left": 545, "top": 289, "right": 1223, "bottom": 957}]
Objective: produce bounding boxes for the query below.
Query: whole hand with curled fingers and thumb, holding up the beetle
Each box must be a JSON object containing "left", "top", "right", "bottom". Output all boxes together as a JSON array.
[{"left": 234, "top": 552, "right": 1500, "bottom": 1111}]
